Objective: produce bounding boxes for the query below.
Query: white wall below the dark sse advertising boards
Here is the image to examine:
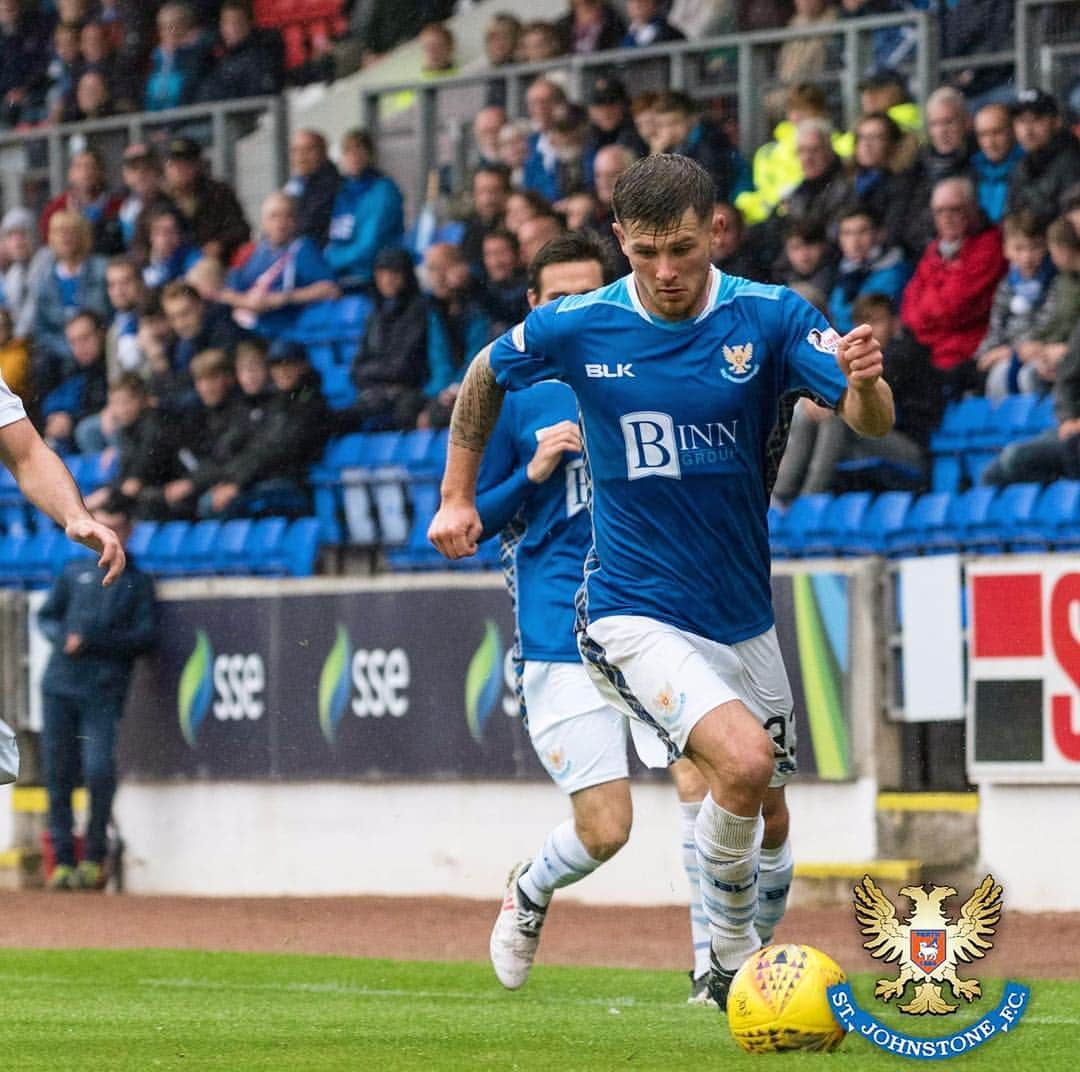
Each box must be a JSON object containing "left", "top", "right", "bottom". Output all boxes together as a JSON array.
[{"left": 117, "top": 778, "right": 875, "bottom": 905}]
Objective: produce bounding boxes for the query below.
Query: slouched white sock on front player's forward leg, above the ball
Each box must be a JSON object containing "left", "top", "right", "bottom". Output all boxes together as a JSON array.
[{"left": 694, "top": 793, "right": 765, "bottom": 972}]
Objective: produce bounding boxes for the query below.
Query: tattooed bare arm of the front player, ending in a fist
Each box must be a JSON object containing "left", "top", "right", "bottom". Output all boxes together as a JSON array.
[{"left": 428, "top": 345, "right": 503, "bottom": 558}]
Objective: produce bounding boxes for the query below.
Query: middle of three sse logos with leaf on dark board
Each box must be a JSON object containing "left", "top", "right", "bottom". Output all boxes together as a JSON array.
[{"left": 319, "top": 625, "right": 411, "bottom": 744}]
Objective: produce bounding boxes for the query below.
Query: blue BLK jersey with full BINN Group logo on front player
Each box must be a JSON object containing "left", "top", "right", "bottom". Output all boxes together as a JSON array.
[{"left": 491, "top": 269, "right": 847, "bottom": 643}]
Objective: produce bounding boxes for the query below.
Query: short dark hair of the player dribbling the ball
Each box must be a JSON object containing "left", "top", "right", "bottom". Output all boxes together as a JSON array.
[{"left": 611, "top": 153, "right": 716, "bottom": 231}]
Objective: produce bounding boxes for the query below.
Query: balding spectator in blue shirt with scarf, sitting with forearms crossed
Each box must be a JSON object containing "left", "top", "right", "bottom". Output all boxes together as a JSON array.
[{"left": 218, "top": 193, "right": 341, "bottom": 337}]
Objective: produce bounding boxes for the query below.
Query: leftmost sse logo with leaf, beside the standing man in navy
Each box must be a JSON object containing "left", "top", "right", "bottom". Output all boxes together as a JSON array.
[{"left": 177, "top": 629, "right": 267, "bottom": 748}]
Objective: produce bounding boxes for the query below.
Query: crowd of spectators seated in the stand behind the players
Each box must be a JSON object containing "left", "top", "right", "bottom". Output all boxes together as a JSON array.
[{"left": 0, "top": 0, "right": 1080, "bottom": 531}]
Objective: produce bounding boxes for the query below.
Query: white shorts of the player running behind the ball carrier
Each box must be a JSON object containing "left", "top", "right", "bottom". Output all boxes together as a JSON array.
[{"left": 522, "top": 660, "right": 667, "bottom": 793}]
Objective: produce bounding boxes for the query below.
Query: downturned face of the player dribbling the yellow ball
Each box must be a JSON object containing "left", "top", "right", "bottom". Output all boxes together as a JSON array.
[{"left": 612, "top": 207, "right": 720, "bottom": 321}]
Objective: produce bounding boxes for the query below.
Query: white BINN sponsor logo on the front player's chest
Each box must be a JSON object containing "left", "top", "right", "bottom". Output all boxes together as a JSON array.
[{"left": 619, "top": 410, "right": 739, "bottom": 480}]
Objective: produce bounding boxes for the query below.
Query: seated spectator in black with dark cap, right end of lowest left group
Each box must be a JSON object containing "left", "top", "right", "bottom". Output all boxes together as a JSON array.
[{"left": 199, "top": 339, "right": 329, "bottom": 519}]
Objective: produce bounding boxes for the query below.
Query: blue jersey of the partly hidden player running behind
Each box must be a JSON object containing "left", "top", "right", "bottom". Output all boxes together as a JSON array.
[{"left": 476, "top": 380, "right": 592, "bottom": 663}]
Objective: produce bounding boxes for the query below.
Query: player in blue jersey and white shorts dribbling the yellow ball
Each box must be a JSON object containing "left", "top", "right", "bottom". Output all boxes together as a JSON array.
[{"left": 430, "top": 154, "right": 893, "bottom": 1008}]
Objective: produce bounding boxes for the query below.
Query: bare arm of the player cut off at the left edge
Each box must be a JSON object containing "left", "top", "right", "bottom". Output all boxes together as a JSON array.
[{"left": 0, "top": 418, "right": 126, "bottom": 584}]
